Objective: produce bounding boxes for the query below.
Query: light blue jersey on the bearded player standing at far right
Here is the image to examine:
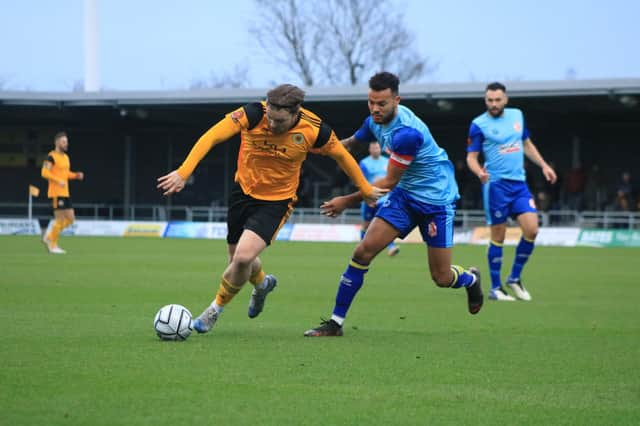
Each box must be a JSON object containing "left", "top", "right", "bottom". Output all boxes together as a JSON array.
[{"left": 467, "top": 108, "right": 529, "bottom": 182}]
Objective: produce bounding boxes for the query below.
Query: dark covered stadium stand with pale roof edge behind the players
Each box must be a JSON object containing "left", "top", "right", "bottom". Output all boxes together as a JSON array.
[{"left": 0, "top": 79, "right": 640, "bottom": 229}]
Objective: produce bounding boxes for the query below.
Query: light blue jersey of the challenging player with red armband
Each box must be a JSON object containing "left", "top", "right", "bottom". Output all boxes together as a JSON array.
[{"left": 355, "top": 105, "right": 460, "bottom": 206}]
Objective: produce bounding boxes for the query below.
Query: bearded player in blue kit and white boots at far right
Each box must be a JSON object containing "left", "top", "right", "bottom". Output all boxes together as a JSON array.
[{"left": 467, "top": 83, "right": 557, "bottom": 301}]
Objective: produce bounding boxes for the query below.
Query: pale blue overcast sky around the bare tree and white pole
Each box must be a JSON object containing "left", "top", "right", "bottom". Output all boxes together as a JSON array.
[{"left": 0, "top": 0, "right": 640, "bottom": 91}]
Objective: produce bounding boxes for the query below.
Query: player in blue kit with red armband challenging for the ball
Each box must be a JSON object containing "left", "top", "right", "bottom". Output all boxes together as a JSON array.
[{"left": 304, "top": 72, "right": 483, "bottom": 337}]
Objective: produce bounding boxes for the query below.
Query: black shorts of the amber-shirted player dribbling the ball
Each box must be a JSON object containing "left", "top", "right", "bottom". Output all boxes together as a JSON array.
[{"left": 227, "top": 183, "right": 293, "bottom": 245}]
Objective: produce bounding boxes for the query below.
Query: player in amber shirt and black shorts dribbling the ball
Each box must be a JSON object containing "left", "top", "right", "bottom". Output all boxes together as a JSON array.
[{"left": 158, "top": 84, "right": 385, "bottom": 333}]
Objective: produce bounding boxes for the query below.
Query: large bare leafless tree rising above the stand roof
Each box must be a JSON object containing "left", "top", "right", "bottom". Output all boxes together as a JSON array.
[{"left": 250, "top": 0, "right": 435, "bottom": 86}]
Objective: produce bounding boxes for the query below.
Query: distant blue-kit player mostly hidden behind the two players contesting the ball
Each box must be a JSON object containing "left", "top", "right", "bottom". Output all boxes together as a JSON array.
[{"left": 358, "top": 141, "right": 400, "bottom": 256}]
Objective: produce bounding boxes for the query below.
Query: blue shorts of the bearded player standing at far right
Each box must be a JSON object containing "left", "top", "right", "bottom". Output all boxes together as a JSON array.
[{"left": 482, "top": 179, "right": 538, "bottom": 225}]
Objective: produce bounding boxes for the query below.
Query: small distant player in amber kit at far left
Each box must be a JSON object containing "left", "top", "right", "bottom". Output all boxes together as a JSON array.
[{"left": 41, "top": 132, "right": 84, "bottom": 254}]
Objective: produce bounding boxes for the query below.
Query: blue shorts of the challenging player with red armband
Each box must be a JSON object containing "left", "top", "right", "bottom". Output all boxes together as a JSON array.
[{"left": 376, "top": 188, "right": 456, "bottom": 248}]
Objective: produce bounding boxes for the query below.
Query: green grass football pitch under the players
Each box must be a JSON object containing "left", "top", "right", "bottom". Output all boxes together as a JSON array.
[{"left": 0, "top": 236, "right": 640, "bottom": 426}]
